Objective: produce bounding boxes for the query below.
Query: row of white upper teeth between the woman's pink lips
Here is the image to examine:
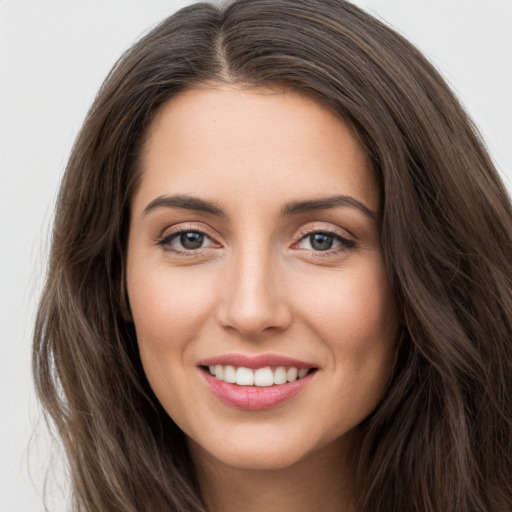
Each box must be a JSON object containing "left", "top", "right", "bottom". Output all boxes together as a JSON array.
[{"left": 208, "top": 364, "right": 308, "bottom": 387}]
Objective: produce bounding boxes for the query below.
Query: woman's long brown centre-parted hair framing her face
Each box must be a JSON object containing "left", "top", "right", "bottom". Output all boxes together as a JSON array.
[{"left": 33, "top": 0, "right": 512, "bottom": 512}]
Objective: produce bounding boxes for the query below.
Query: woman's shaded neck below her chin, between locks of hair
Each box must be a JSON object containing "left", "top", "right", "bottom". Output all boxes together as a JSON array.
[{"left": 190, "top": 436, "right": 355, "bottom": 512}]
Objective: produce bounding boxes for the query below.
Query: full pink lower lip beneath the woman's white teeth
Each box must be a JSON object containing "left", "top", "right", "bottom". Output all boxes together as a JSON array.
[{"left": 201, "top": 370, "right": 316, "bottom": 411}]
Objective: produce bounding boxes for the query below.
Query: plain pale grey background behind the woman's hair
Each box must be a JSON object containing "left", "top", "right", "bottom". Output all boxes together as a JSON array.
[{"left": 0, "top": 0, "right": 512, "bottom": 512}]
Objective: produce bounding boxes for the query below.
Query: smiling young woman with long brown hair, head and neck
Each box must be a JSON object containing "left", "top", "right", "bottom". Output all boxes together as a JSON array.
[{"left": 34, "top": 0, "right": 512, "bottom": 512}]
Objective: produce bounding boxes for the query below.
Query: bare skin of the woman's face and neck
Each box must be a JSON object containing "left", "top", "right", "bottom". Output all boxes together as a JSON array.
[{"left": 127, "top": 84, "right": 398, "bottom": 512}]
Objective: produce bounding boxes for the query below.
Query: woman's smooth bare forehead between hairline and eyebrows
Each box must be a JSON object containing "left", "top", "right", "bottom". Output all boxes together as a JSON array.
[{"left": 135, "top": 85, "right": 379, "bottom": 216}]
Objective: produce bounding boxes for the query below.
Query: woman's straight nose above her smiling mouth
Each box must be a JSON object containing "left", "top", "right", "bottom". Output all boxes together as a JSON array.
[{"left": 218, "top": 247, "right": 292, "bottom": 338}]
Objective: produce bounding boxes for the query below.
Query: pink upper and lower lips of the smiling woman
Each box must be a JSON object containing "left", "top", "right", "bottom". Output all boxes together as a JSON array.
[{"left": 198, "top": 354, "right": 318, "bottom": 411}]
